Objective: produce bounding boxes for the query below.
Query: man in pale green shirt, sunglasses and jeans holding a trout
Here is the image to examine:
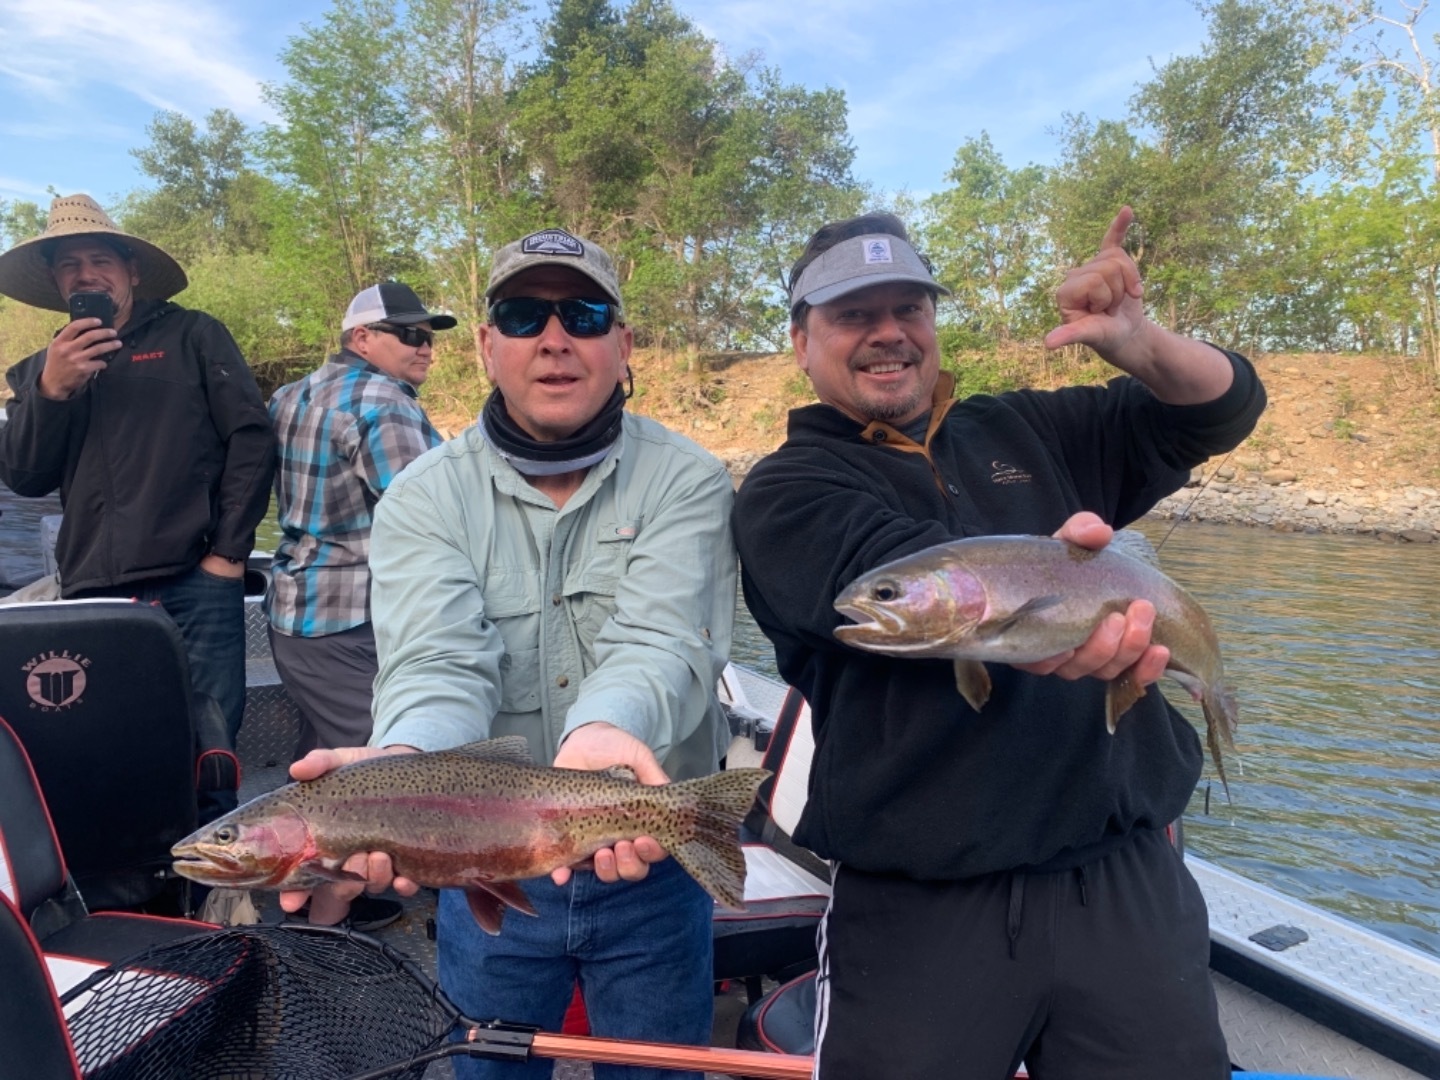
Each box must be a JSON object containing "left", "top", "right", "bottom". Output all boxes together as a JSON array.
[{"left": 282, "top": 229, "right": 736, "bottom": 1080}]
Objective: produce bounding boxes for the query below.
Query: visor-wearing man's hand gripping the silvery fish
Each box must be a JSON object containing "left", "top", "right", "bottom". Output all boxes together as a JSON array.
[{"left": 1015, "top": 510, "right": 1169, "bottom": 687}]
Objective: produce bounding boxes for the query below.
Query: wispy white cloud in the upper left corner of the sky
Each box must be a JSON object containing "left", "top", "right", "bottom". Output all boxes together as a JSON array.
[{"left": 0, "top": 0, "right": 268, "bottom": 121}]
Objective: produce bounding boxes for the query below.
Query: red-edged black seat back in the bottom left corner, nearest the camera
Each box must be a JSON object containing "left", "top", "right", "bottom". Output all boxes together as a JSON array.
[{"left": 0, "top": 896, "right": 81, "bottom": 1080}]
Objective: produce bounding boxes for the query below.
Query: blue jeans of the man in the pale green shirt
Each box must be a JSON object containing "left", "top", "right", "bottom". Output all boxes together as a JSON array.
[{"left": 436, "top": 860, "right": 714, "bottom": 1080}]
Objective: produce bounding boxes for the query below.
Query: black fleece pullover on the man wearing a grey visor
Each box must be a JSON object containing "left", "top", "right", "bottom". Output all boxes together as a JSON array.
[{"left": 733, "top": 354, "right": 1264, "bottom": 880}]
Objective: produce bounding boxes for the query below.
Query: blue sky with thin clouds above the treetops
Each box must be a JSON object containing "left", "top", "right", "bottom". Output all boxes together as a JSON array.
[{"left": 0, "top": 0, "right": 1204, "bottom": 213}]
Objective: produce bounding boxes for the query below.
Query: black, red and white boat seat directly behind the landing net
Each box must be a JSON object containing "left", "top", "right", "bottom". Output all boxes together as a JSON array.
[{"left": 0, "top": 720, "right": 216, "bottom": 961}]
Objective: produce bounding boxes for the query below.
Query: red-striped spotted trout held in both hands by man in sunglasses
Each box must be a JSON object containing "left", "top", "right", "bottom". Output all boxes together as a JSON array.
[{"left": 170, "top": 736, "right": 769, "bottom": 933}]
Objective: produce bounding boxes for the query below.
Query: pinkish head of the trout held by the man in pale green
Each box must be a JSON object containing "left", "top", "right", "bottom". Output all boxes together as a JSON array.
[{"left": 170, "top": 801, "right": 314, "bottom": 888}]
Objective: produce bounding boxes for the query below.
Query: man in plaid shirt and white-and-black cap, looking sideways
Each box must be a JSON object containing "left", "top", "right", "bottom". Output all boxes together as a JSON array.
[{"left": 265, "top": 288, "right": 455, "bottom": 757}]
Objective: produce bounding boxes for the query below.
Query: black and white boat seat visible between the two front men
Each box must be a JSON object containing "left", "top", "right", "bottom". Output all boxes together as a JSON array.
[{"left": 713, "top": 690, "right": 829, "bottom": 1002}]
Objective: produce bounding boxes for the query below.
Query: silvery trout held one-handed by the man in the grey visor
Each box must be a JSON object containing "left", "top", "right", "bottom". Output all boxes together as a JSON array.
[{"left": 835, "top": 533, "right": 1237, "bottom": 793}]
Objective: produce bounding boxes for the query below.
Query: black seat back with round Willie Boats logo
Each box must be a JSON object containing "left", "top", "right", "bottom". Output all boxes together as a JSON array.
[{"left": 0, "top": 600, "right": 238, "bottom": 909}]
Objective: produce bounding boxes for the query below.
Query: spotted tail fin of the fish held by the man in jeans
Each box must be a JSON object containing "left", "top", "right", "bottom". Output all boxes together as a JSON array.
[{"left": 655, "top": 769, "right": 770, "bottom": 912}]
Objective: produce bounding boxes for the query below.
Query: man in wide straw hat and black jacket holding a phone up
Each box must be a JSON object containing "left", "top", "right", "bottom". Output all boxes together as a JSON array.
[{"left": 0, "top": 194, "right": 275, "bottom": 815}]
